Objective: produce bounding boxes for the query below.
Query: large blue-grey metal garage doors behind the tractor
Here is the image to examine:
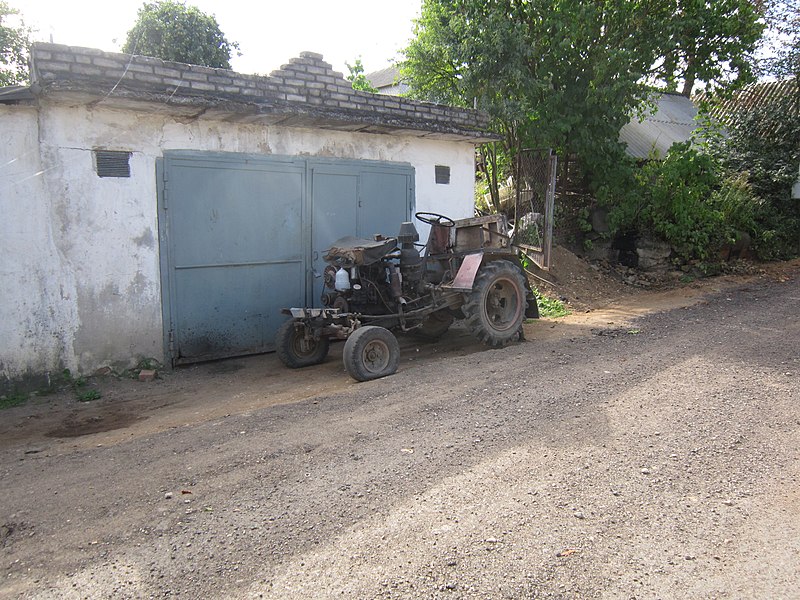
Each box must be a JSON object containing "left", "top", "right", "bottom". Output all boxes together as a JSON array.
[{"left": 159, "top": 151, "right": 414, "bottom": 364}]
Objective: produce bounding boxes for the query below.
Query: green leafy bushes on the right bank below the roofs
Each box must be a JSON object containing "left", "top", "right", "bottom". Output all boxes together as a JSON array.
[{"left": 587, "top": 80, "right": 800, "bottom": 261}]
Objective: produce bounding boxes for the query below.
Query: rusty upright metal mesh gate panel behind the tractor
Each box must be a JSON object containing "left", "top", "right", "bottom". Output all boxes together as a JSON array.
[{"left": 514, "top": 150, "right": 558, "bottom": 269}]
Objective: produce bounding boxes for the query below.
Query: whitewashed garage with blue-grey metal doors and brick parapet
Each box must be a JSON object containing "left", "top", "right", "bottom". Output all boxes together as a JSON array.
[{"left": 0, "top": 43, "right": 498, "bottom": 389}]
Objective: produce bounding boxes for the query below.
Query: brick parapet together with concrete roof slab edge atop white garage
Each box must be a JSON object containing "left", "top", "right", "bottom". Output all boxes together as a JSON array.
[{"left": 12, "top": 42, "right": 498, "bottom": 143}]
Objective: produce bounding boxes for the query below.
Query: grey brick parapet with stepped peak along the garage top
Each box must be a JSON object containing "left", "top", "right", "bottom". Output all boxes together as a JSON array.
[{"left": 31, "top": 43, "right": 493, "bottom": 138}]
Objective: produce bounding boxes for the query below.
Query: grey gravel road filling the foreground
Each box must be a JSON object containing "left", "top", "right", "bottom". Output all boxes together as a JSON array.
[{"left": 0, "top": 269, "right": 800, "bottom": 599}]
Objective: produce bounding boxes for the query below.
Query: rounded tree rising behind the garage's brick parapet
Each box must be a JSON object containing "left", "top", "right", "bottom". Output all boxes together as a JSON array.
[{"left": 122, "top": 0, "right": 239, "bottom": 69}]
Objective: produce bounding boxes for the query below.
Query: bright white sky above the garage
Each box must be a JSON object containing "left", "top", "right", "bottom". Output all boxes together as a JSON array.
[{"left": 12, "top": 0, "right": 421, "bottom": 75}]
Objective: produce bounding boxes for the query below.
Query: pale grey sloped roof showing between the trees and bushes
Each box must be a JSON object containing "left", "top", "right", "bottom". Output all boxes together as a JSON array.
[{"left": 619, "top": 92, "right": 697, "bottom": 159}]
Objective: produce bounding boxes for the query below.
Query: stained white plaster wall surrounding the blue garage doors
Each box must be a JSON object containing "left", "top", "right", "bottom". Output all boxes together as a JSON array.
[{"left": 0, "top": 103, "right": 474, "bottom": 380}]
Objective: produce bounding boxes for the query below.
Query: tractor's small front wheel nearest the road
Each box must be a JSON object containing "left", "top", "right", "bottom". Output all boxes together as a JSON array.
[{"left": 342, "top": 325, "right": 400, "bottom": 381}]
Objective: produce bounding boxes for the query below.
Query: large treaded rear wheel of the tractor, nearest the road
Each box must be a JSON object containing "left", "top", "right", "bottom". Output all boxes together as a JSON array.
[{"left": 462, "top": 260, "right": 527, "bottom": 348}]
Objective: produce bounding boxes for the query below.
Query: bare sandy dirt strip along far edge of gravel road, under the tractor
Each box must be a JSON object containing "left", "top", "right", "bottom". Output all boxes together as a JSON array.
[{"left": 0, "top": 247, "right": 800, "bottom": 449}]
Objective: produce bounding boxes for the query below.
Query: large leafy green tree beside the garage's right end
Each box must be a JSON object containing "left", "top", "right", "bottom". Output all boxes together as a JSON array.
[{"left": 401, "top": 0, "right": 669, "bottom": 208}]
